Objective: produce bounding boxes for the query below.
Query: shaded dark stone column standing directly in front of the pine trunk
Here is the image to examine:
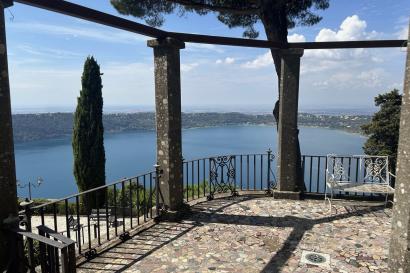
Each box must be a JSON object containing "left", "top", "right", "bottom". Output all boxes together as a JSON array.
[{"left": 277, "top": 48, "right": 303, "bottom": 191}]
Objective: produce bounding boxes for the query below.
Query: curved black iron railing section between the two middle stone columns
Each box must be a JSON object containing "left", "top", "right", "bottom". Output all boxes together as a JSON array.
[{"left": 183, "top": 149, "right": 276, "bottom": 201}]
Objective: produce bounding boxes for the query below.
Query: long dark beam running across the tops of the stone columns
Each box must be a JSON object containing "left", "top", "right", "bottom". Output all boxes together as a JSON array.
[{"left": 15, "top": 0, "right": 407, "bottom": 49}]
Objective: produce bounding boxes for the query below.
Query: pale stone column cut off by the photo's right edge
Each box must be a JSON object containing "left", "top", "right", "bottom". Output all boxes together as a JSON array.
[{"left": 389, "top": 23, "right": 410, "bottom": 273}]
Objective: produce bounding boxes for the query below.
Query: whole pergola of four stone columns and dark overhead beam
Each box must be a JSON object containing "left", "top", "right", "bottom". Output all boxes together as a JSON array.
[{"left": 0, "top": 0, "right": 410, "bottom": 272}]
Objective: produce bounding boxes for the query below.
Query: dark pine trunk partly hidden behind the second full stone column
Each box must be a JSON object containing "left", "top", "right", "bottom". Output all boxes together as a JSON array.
[{"left": 260, "top": 0, "right": 306, "bottom": 191}]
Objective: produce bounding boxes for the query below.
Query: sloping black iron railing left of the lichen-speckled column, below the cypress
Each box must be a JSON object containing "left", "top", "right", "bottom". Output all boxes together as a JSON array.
[{"left": 20, "top": 169, "right": 159, "bottom": 263}]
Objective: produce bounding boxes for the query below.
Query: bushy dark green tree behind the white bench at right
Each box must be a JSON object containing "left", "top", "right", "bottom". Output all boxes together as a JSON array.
[{"left": 362, "top": 89, "right": 402, "bottom": 170}]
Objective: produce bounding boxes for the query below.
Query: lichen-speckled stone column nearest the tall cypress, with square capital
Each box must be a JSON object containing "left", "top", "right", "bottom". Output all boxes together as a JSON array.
[{"left": 148, "top": 38, "right": 185, "bottom": 211}]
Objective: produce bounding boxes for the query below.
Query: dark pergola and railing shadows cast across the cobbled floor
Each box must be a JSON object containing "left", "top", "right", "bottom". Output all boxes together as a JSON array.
[{"left": 78, "top": 196, "right": 384, "bottom": 273}]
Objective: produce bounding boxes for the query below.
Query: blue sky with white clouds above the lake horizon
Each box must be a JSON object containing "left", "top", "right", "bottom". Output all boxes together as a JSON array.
[{"left": 5, "top": 0, "right": 410, "bottom": 112}]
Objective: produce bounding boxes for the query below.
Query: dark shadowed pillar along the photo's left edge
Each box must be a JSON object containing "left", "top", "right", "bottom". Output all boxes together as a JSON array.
[{"left": 0, "top": 1, "right": 18, "bottom": 272}]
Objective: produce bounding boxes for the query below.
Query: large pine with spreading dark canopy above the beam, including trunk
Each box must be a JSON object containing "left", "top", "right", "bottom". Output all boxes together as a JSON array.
[{"left": 111, "top": 0, "right": 329, "bottom": 189}]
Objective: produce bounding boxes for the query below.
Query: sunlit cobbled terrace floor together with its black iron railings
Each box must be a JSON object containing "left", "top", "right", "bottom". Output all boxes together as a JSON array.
[{"left": 9, "top": 153, "right": 400, "bottom": 272}]
